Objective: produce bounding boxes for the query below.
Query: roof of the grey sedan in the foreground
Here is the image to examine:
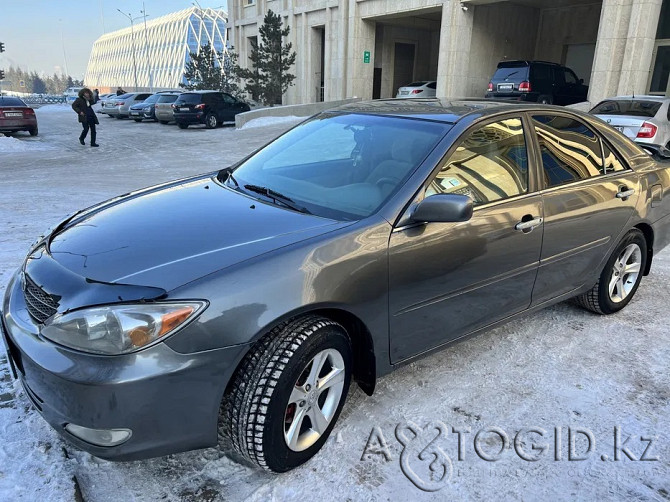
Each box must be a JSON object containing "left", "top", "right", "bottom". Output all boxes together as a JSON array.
[{"left": 328, "top": 98, "right": 581, "bottom": 124}]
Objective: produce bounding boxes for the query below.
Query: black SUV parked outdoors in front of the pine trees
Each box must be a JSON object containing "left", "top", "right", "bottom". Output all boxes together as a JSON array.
[{"left": 172, "top": 91, "right": 250, "bottom": 129}]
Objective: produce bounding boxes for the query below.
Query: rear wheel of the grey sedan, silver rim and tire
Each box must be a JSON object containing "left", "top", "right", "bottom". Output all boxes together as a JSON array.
[{"left": 576, "top": 229, "right": 647, "bottom": 314}]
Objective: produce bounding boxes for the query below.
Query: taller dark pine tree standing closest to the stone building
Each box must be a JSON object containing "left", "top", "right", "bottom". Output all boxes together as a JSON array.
[{"left": 239, "top": 10, "right": 296, "bottom": 105}]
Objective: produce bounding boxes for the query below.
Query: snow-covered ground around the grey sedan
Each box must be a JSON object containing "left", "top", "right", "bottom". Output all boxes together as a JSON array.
[{"left": 0, "top": 105, "right": 670, "bottom": 502}]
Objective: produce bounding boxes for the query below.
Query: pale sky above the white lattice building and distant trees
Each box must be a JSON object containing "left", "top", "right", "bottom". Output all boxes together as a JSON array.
[{"left": 0, "top": 0, "right": 227, "bottom": 79}]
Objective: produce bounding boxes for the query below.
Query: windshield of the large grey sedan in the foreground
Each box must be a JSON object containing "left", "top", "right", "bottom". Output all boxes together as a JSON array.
[{"left": 226, "top": 113, "right": 451, "bottom": 220}]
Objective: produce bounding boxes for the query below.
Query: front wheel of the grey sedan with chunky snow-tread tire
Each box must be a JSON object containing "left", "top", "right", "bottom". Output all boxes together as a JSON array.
[{"left": 221, "top": 315, "right": 352, "bottom": 472}]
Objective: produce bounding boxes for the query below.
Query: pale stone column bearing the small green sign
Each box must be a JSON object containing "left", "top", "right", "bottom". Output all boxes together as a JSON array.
[{"left": 342, "top": 0, "right": 376, "bottom": 99}]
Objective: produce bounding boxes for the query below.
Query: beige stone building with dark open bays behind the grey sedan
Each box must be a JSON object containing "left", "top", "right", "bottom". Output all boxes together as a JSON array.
[{"left": 228, "top": 0, "right": 670, "bottom": 104}]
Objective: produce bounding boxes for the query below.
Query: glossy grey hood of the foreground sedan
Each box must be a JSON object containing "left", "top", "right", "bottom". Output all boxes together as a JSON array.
[{"left": 48, "top": 176, "right": 350, "bottom": 291}]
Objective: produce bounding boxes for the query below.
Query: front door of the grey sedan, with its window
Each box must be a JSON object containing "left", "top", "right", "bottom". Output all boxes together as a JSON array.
[{"left": 389, "top": 116, "right": 542, "bottom": 363}]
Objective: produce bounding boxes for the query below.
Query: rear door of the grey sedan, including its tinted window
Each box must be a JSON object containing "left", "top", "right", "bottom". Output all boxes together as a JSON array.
[{"left": 531, "top": 113, "right": 639, "bottom": 305}]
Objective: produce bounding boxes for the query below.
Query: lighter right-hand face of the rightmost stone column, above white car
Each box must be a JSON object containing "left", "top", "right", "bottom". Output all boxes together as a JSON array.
[{"left": 617, "top": 0, "right": 663, "bottom": 95}]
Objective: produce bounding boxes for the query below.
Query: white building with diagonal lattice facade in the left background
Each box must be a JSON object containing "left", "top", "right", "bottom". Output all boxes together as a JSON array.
[{"left": 84, "top": 7, "right": 227, "bottom": 92}]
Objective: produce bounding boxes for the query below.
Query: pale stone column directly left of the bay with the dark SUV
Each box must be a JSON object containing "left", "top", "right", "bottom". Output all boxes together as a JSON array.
[{"left": 437, "top": 0, "right": 476, "bottom": 97}]
